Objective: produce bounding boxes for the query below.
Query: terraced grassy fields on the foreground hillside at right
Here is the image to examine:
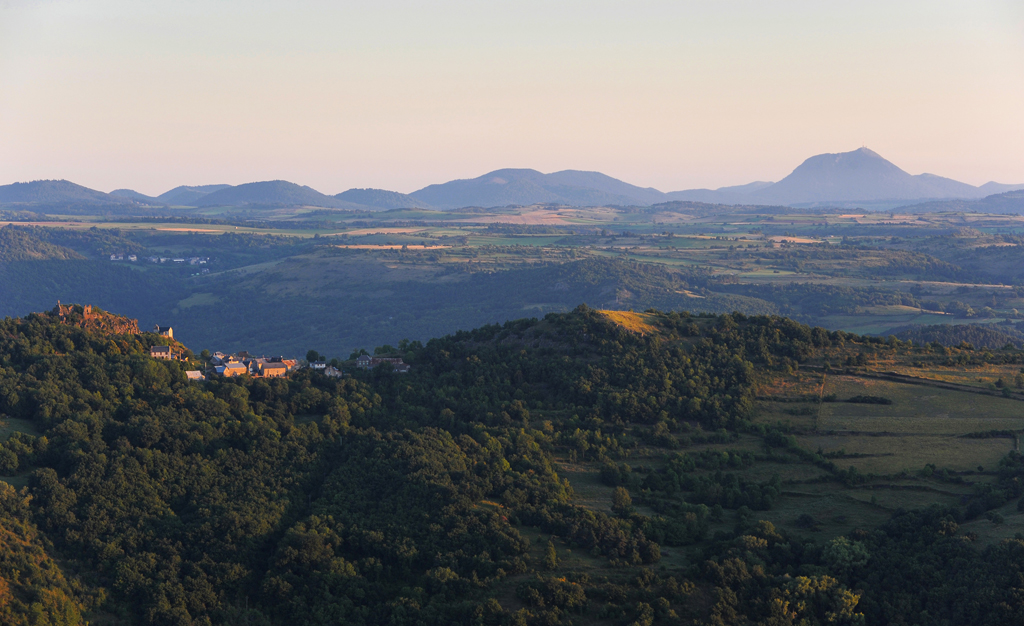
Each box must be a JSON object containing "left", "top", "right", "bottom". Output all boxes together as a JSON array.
[{"left": 726, "top": 366, "right": 1024, "bottom": 545}]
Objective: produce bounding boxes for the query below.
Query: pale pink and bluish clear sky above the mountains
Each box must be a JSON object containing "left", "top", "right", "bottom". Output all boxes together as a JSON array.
[{"left": 0, "top": 0, "right": 1024, "bottom": 195}]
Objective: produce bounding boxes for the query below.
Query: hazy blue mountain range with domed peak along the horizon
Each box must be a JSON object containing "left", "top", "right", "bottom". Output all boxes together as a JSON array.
[{"left": 0, "top": 148, "right": 1024, "bottom": 212}]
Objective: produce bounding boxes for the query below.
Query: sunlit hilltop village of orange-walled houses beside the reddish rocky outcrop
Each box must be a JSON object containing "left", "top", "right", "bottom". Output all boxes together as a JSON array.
[{"left": 150, "top": 325, "right": 412, "bottom": 381}]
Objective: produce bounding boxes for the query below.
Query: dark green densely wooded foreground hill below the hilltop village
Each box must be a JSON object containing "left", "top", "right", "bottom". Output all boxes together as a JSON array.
[{"left": 0, "top": 305, "right": 1024, "bottom": 625}]
